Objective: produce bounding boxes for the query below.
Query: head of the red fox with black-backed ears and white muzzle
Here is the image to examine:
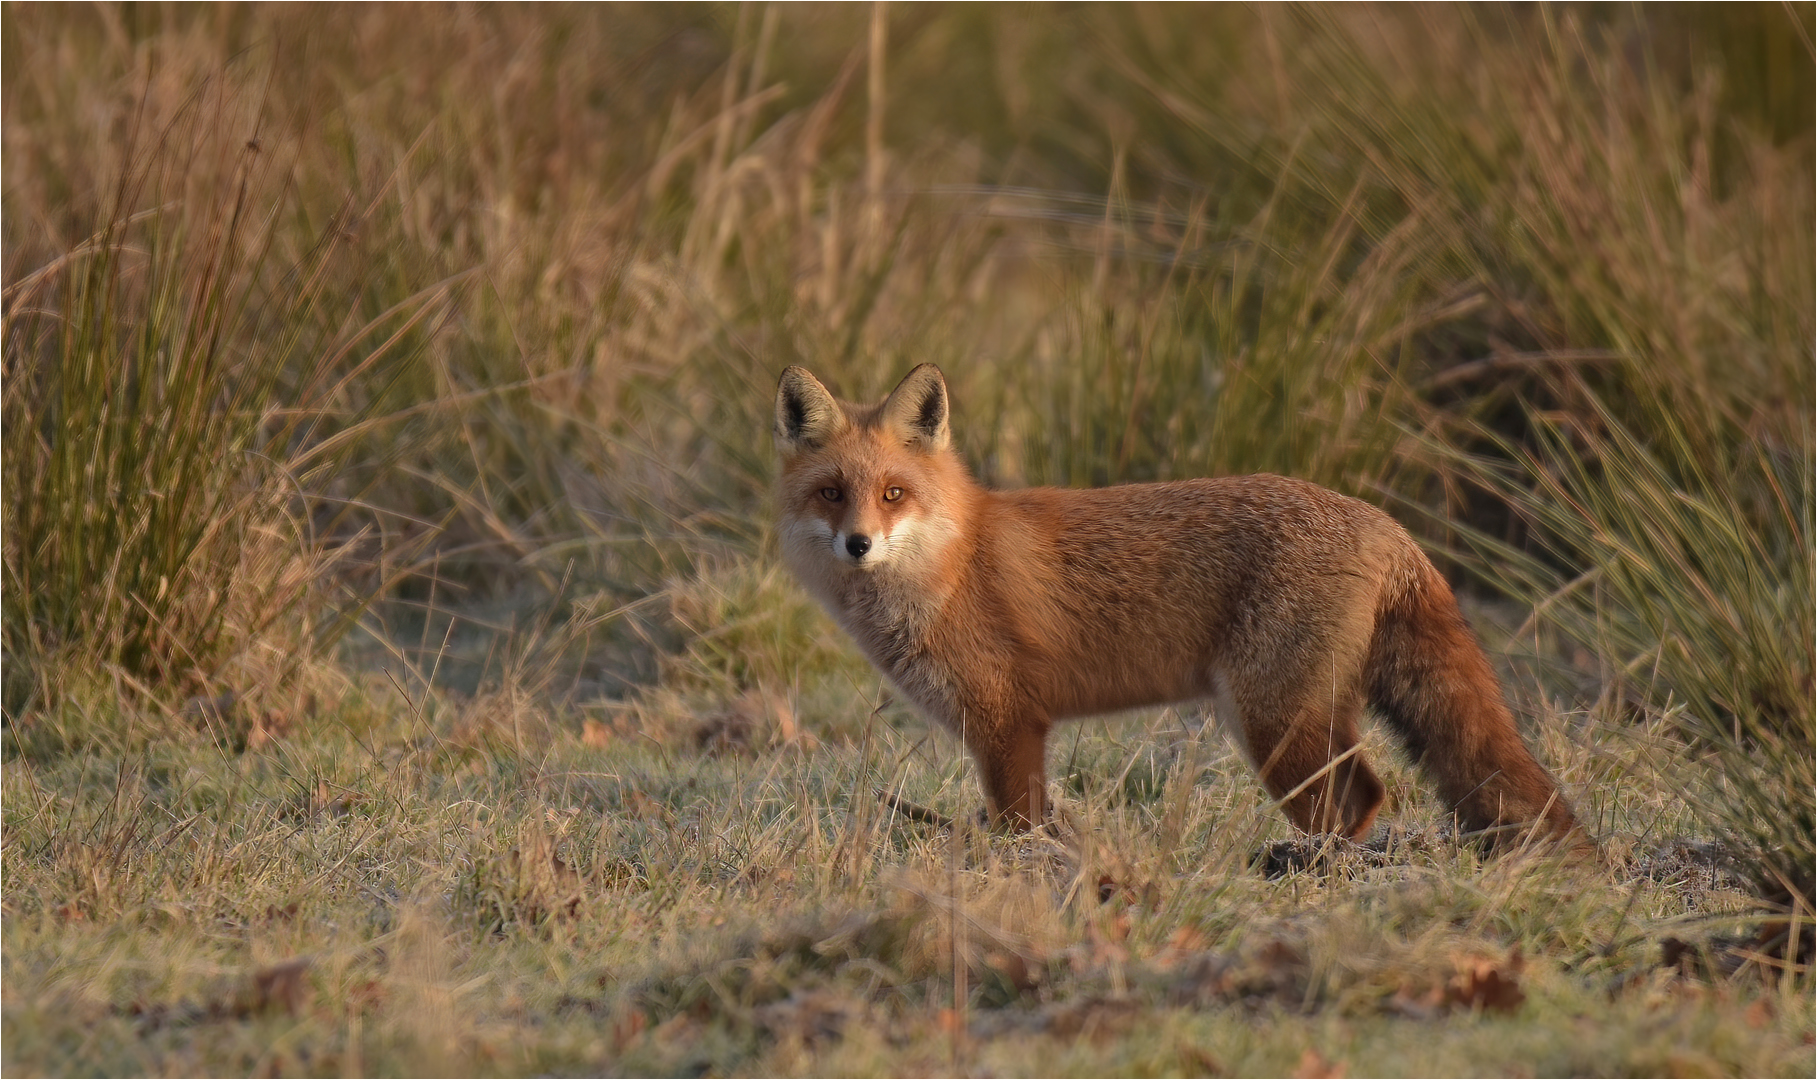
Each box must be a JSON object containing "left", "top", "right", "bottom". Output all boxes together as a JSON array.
[{"left": 776, "top": 364, "right": 970, "bottom": 573}]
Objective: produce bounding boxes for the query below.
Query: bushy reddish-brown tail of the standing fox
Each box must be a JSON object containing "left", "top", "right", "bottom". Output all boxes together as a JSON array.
[{"left": 1368, "top": 551, "right": 1584, "bottom": 842}]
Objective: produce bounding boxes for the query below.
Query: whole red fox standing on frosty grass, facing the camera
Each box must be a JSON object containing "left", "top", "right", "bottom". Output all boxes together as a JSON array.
[{"left": 776, "top": 364, "right": 1583, "bottom": 842}]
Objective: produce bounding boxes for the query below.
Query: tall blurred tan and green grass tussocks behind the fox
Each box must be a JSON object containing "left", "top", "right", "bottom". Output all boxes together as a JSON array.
[{"left": 0, "top": 4, "right": 1817, "bottom": 911}]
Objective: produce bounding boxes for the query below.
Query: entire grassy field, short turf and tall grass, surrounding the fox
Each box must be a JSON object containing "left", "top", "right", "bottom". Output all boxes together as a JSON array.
[{"left": 0, "top": 4, "right": 1817, "bottom": 1076}]
